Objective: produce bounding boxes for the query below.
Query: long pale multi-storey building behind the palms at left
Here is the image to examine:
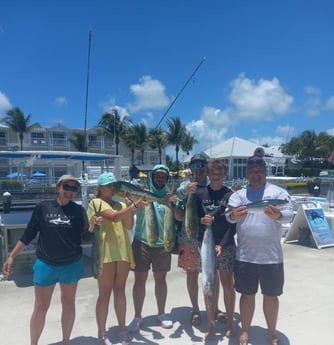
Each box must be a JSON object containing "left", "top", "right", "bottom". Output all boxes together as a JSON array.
[{"left": 0, "top": 124, "right": 164, "bottom": 179}]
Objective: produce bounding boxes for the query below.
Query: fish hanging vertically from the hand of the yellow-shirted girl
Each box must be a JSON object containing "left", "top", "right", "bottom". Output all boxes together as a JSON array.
[{"left": 91, "top": 202, "right": 103, "bottom": 279}]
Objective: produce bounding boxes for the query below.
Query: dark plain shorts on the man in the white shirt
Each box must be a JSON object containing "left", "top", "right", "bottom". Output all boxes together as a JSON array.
[{"left": 234, "top": 260, "right": 284, "bottom": 296}]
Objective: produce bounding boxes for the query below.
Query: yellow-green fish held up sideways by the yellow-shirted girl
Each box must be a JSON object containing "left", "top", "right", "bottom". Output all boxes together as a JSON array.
[{"left": 112, "top": 181, "right": 170, "bottom": 206}]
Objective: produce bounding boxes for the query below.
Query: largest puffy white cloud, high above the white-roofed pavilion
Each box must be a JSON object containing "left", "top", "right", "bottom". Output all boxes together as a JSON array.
[{"left": 229, "top": 73, "right": 293, "bottom": 121}]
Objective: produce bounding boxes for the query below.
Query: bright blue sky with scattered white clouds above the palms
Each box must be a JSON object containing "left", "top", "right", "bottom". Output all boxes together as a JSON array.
[{"left": 0, "top": 0, "right": 334, "bottom": 159}]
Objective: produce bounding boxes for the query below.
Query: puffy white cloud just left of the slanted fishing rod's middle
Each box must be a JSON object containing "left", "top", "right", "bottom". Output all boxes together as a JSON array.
[{"left": 127, "top": 76, "right": 170, "bottom": 112}]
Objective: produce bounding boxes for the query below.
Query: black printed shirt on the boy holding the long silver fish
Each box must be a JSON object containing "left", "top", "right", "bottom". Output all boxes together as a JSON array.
[{"left": 194, "top": 185, "right": 236, "bottom": 247}]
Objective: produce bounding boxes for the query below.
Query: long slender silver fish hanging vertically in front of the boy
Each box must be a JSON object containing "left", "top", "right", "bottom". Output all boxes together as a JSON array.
[{"left": 201, "top": 226, "right": 217, "bottom": 306}]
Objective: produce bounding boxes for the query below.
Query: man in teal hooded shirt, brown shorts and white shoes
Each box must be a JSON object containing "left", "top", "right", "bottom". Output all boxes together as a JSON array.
[{"left": 128, "top": 164, "right": 181, "bottom": 332}]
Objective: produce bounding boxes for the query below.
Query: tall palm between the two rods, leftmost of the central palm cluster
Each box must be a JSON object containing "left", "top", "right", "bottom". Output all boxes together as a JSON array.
[{"left": 99, "top": 108, "right": 131, "bottom": 155}]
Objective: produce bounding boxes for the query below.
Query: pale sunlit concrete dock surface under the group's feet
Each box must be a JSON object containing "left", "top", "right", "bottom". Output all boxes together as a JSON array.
[{"left": 0, "top": 244, "right": 334, "bottom": 345}]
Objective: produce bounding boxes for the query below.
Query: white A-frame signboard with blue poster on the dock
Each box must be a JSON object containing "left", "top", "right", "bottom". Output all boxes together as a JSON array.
[{"left": 284, "top": 203, "right": 334, "bottom": 249}]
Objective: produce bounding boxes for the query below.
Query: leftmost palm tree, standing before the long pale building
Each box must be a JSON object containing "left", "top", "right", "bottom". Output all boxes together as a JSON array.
[{"left": 2, "top": 107, "right": 40, "bottom": 151}]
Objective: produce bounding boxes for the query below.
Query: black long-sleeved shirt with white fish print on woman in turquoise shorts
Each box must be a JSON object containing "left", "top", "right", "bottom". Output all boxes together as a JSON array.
[{"left": 20, "top": 200, "right": 90, "bottom": 266}]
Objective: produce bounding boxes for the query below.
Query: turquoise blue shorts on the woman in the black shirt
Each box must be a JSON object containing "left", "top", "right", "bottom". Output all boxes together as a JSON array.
[{"left": 33, "top": 259, "right": 83, "bottom": 287}]
